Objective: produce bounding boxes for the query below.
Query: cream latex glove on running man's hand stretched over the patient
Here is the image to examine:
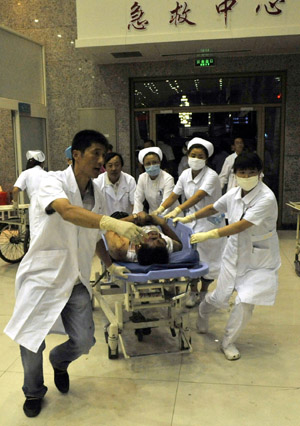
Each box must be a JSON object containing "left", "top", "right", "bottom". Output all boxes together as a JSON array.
[{"left": 99, "top": 216, "right": 147, "bottom": 244}]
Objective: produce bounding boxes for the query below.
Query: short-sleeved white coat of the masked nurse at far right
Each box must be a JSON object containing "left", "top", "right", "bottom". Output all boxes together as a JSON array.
[{"left": 210, "top": 182, "right": 280, "bottom": 307}]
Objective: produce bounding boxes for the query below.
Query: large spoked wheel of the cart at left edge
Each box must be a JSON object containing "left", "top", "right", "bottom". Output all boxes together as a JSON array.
[{"left": 0, "top": 224, "right": 30, "bottom": 263}]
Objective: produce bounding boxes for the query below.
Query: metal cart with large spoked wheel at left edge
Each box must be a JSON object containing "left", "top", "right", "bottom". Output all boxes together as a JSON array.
[{"left": 0, "top": 204, "right": 30, "bottom": 263}]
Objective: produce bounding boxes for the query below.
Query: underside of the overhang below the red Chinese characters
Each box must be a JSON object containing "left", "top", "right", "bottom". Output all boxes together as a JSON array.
[{"left": 78, "top": 35, "right": 300, "bottom": 64}]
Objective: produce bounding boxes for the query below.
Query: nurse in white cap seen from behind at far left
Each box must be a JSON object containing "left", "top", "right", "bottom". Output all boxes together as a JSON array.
[{"left": 12, "top": 150, "right": 47, "bottom": 241}]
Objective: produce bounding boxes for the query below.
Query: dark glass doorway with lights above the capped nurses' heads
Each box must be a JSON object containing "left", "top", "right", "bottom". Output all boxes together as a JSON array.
[{"left": 151, "top": 108, "right": 263, "bottom": 178}]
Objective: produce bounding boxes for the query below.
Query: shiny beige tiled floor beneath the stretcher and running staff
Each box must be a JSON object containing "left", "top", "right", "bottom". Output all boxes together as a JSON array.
[{"left": 0, "top": 231, "right": 300, "bottom": 426}]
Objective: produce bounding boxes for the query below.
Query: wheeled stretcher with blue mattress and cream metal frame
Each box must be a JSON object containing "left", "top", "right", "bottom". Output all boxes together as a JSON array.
[{"left": 93, "top": 220, "right": 208, "bottom": 359}]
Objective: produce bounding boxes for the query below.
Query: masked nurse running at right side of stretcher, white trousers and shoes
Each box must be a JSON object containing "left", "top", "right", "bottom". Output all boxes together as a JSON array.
[{"left": 183, "top": 153, "right": 280, "bottom": 360}]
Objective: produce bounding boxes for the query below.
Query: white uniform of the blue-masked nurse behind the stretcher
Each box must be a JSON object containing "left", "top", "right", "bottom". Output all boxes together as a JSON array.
[{"left": 133, "top": 170, "right": 179, "bottom": 213}]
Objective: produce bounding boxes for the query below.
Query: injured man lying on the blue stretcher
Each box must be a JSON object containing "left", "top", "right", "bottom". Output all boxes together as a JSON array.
[{"left": 105, "top": 212, "right": 182, "bottom": 265}]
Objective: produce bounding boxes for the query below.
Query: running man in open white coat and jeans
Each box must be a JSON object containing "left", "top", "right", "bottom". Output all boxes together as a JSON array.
[{"left": 5, "top": 130, "right": 144, "bottom": 417}]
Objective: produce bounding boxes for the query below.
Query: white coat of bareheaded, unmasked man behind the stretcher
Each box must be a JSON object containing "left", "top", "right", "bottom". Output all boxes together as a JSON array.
[{"left": 94, "top": 172, "right": 136, "bottom": 216}]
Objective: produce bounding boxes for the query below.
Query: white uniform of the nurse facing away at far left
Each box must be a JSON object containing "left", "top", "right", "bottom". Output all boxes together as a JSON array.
[{"left": 14, "top": 166, "right": 47, "bottom": 242}]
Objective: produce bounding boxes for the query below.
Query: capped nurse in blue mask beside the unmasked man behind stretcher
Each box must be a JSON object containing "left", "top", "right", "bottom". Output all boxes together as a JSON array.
[{"left": 133, "top": 146, "right": 174, "bottom": 213}]
